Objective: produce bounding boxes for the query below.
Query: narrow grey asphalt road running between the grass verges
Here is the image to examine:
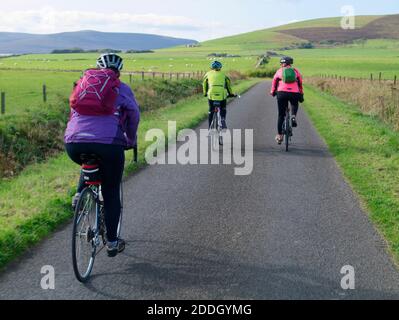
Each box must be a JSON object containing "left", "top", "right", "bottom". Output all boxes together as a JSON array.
[{"left": 0, "top": 82, "right": 399, "bottom": 299}]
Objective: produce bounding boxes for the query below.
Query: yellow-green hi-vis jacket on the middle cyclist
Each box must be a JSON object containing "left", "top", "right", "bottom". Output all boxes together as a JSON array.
[{"left": 203, "top": 70, "right": 233, "bottom": 101}]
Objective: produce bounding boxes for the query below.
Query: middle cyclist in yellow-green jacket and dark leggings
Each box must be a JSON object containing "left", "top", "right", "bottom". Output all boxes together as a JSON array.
[{"left": 203, "top": 61, "right": 237, "bottom": 129}]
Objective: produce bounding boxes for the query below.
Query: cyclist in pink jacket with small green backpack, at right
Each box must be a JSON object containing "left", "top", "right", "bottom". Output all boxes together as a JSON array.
[{"left": 270, "top": 57, "right": 304, "bottom": 144}]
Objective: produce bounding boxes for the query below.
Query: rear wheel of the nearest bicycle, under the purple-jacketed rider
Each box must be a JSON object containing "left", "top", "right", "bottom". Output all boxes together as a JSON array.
[{"left": 72, "top": 188, "right": 98, "bottom": 282}]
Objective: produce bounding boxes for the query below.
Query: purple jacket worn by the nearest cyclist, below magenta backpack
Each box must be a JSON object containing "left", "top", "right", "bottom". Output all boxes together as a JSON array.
[{"left": 64, "top": 83, "right": 140, "bottom": 147}]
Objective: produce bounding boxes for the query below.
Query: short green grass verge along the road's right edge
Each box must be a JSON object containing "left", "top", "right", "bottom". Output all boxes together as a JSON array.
[{"left": 305, "top": 86, "right": 399, "bottom": 263}]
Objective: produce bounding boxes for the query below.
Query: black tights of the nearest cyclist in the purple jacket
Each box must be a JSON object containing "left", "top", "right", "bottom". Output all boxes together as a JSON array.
[{"left": 65, "top": 143, "right": 125, "bottom": 242}]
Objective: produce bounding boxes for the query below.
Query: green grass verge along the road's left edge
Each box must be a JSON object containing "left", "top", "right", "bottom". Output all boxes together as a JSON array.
[{"left": 0, "top": 79, "right": 260, "bottom": 268}]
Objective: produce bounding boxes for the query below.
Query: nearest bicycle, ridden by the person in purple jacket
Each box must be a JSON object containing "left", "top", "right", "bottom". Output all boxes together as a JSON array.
[{"left": 72, "top": 154, "right": 123, "bottom": 283}]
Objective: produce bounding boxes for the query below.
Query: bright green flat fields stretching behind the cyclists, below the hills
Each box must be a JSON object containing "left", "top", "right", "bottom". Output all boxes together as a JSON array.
[{"left": 0, "top": 38, "right": 399, "bottom": 113}]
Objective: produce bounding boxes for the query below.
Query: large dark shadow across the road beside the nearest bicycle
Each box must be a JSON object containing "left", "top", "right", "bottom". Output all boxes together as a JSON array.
[{"left": 83, "top": 240, "right": 398, "bottom": 299}]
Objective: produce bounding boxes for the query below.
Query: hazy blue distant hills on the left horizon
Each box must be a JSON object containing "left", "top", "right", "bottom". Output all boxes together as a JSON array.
[{"left": 0, "top": 31, "right": 197, "bottom": 54}]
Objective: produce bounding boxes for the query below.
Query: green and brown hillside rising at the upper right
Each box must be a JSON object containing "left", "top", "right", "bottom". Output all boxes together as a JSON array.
[{"left": 201, "top": 14, "right": 399, "bottom": 53}]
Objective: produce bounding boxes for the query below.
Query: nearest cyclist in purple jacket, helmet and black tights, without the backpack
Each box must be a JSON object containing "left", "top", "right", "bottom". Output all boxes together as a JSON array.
[{"left": 65, "top": 54, "right": 140, "bottom": 257}]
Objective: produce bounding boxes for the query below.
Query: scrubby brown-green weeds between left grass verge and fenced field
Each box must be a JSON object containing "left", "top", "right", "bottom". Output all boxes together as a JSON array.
[{"left": 0, "top": 79, "right": 202, "bottom": 179}]
